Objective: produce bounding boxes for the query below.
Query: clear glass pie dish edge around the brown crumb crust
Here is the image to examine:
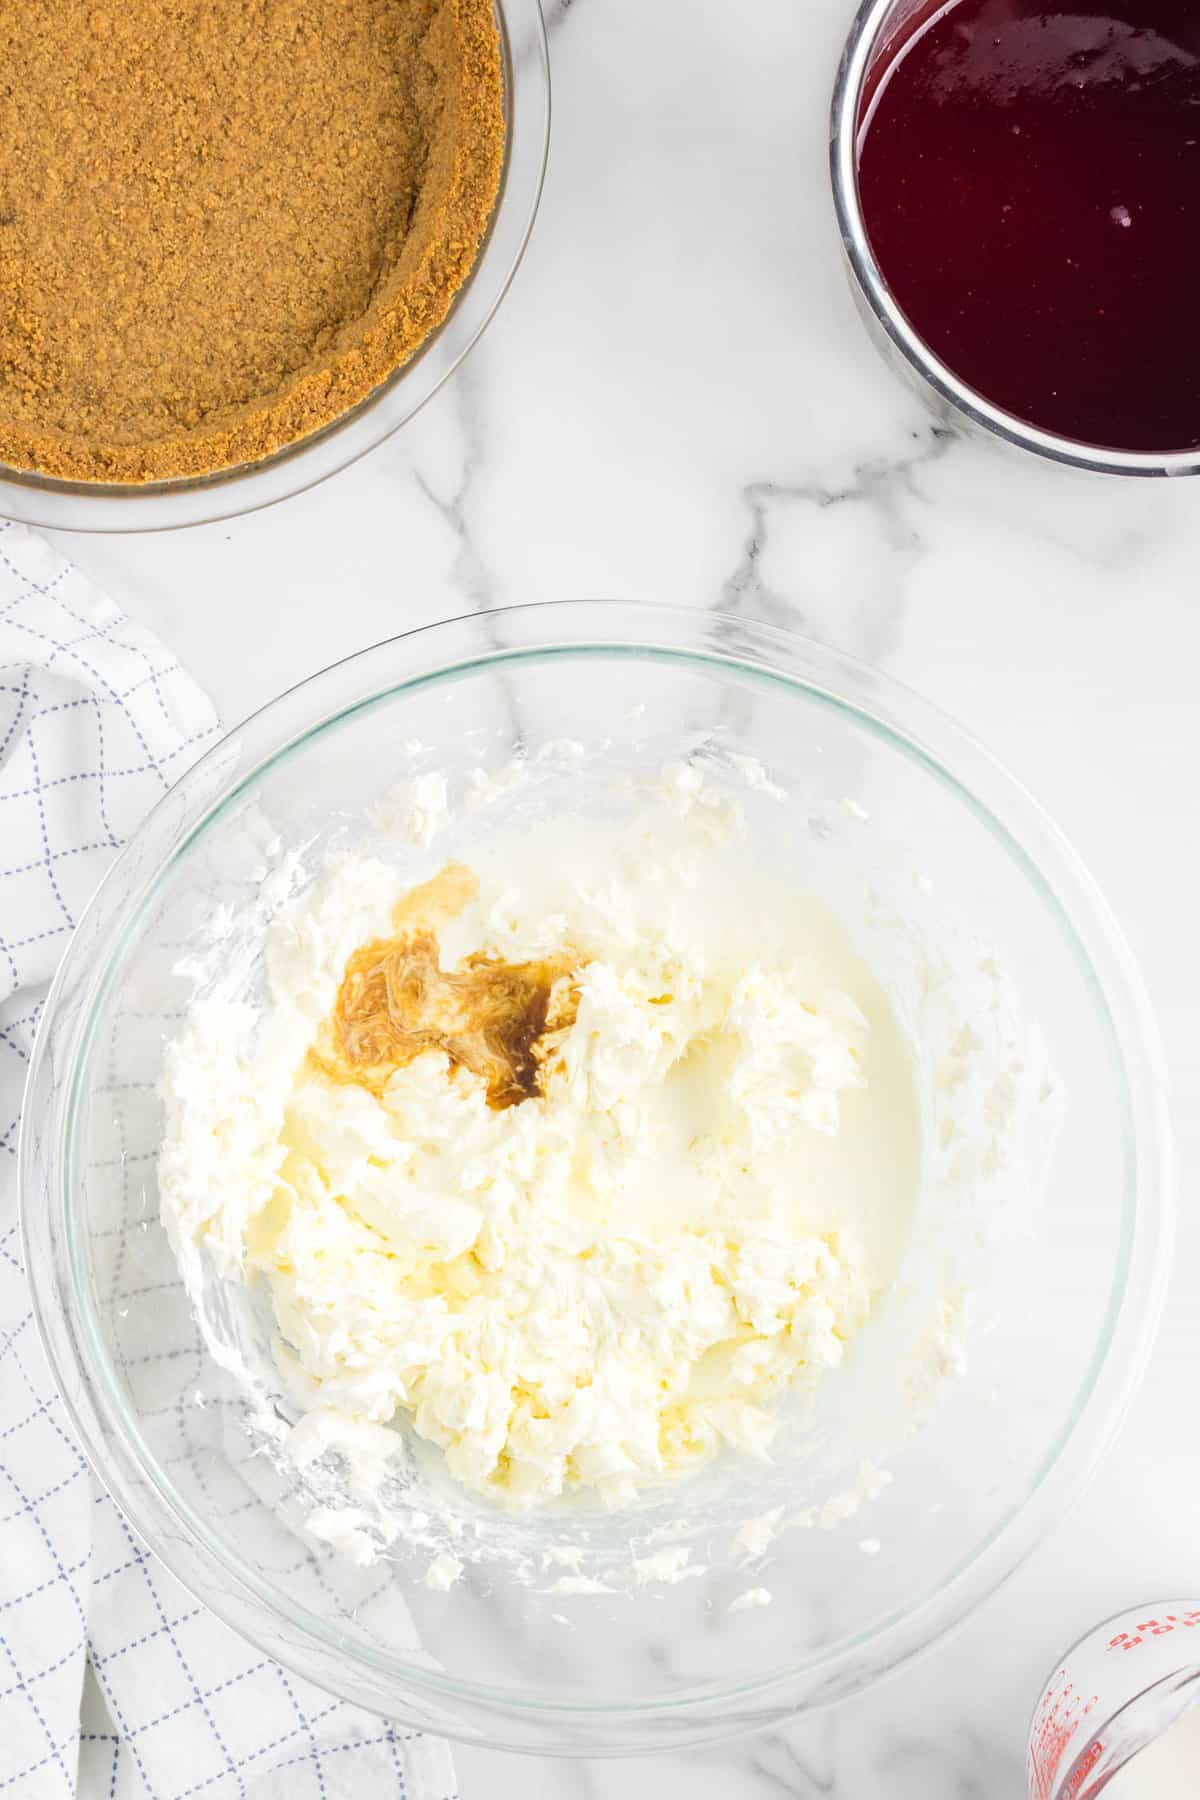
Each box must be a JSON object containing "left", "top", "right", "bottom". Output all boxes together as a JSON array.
[{"left": 0, "top": 0, "right": 551, "bottom": 531}]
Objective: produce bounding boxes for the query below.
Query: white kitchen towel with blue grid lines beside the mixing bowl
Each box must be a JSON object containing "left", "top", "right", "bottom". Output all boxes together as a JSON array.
[{"left": 0, "top": 522, "right": 453, "bottom": 1800}]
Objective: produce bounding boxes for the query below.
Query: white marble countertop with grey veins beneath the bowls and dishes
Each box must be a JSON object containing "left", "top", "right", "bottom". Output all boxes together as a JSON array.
[{"left": 51, "top": 0, "right": 1200, "bottom": 1800}]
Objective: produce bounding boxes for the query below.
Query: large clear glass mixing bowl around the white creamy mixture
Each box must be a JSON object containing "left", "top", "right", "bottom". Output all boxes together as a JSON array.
[{"left": 22, "top": 601, "right": 1171, "bottom": 1753}]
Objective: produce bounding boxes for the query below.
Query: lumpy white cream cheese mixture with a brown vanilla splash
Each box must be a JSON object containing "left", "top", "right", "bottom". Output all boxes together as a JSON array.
[{"left": 160, "top": 767, "right": 919, "bottom": 1512}]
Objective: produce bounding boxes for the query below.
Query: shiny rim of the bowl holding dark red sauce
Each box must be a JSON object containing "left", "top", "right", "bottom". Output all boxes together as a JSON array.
[{"left": 829, "top": 0, "right": 1200, "bottom": 475}]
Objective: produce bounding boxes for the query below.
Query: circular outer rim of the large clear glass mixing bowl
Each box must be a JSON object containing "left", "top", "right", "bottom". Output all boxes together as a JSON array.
[{"left": 18, "top": 601, "right": 1171, "bottom": 1748}]
